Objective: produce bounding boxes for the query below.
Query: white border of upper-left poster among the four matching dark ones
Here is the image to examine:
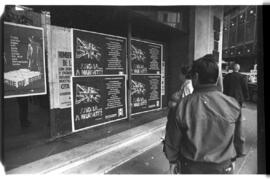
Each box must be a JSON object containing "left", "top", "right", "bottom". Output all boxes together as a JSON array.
[{"left": 71, "top": 28, "right": 128, "bottom": 76}]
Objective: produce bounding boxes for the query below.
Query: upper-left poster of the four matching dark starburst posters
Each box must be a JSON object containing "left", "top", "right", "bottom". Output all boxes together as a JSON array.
[{"left": 72, "top": 29, "right": 127, "bottom": 76}]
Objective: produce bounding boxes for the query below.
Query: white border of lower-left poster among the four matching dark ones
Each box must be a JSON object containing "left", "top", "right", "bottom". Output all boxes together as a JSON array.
[{"left": 70, "top": 75, "right": 128, "bottom": 133}]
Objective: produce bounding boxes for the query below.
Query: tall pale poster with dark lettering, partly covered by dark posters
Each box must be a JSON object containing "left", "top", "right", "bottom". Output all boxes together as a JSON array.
[{"left": 47, "top": 25, "right": 72, "bottom": 109}]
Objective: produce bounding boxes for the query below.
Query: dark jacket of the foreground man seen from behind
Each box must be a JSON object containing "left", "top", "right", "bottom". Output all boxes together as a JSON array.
[{"left": 164, "top": 85, "right": 245, "bottom": 164}]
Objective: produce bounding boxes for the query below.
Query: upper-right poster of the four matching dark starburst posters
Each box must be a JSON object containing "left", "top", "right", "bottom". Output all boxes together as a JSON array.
[{"left": 131, "top": 39, "right": 163, "bottom": 74}]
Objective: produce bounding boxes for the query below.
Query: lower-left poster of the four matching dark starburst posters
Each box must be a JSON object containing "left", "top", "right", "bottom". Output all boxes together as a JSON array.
[{"left": 71, "top": 75, "right": 127, "bottom": 132}]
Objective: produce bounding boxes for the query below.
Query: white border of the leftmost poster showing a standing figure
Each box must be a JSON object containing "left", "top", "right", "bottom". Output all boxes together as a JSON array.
[{"left": 3, "top": 21, "right": 47, "bottom": 99}]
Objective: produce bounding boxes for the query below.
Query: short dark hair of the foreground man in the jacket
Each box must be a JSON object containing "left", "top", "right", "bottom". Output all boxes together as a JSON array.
[{"left": 192, "top": 54, "right": 218, "bottom": 84}]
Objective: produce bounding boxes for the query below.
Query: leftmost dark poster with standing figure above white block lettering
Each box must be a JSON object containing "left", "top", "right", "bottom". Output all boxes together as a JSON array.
[{"left": 3, "top": 22, "right": 47, "bottom": 98}]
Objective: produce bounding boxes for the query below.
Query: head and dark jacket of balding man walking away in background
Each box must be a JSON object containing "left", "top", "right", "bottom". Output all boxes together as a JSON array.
[{"left": 223, "top": 64, "right": 249, "bottom": 107}]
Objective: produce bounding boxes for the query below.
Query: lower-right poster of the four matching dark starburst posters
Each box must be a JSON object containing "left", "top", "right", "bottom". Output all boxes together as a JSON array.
[{"left": 131, "top": 75, "right": 161, "bottom": 114}]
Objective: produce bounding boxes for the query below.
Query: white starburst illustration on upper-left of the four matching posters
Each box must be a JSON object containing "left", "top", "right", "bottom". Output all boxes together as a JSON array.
[{"left": 76, "top": 37, "right": 101, "bottom": 61}]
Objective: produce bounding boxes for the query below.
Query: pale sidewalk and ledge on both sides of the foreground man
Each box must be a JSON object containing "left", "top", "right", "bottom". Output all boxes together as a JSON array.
[{"left": 7, "top": 104, "right": 257, "bottom": 174}]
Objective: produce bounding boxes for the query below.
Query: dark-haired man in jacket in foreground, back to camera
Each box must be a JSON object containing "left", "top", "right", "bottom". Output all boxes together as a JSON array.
[{"left": 164, "top": 55, "right": 245, "bottom": 174}]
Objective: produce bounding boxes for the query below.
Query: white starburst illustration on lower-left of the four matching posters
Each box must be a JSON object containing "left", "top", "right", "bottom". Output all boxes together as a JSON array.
[{"left": 75, "top": 84, "right": 101, "bottom": 104}]
